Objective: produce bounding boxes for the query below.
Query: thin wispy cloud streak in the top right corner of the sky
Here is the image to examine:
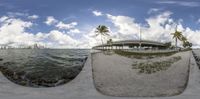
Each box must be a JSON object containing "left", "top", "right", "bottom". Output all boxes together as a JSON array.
[{"left": 157, "top": 1, "right": 200, "bottom": 7}]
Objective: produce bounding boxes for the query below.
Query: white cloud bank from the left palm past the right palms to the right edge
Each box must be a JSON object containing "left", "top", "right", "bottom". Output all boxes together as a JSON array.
[{"left": 101, "top": 11, "right": 200, "bottom": 47}]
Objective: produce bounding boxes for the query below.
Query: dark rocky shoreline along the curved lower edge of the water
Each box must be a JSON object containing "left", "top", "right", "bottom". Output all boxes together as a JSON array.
[{"left": 0, "top": 58, "right": 87, "bottom": 87}]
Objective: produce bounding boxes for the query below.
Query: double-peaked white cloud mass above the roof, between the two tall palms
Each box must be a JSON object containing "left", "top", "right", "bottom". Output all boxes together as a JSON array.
[{"left": 101, "top": 11, "right": 175, "bottom": 42}]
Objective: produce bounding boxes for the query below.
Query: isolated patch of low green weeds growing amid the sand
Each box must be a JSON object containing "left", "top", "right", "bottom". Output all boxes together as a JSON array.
[{"left": 132, "top": 56, "right": 181, "bottom": 74}]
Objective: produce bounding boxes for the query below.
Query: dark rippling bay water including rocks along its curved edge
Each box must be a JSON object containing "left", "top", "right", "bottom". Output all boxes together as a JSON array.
[{"left": 0, "top": 49, "right": 90, "bottom": 87}]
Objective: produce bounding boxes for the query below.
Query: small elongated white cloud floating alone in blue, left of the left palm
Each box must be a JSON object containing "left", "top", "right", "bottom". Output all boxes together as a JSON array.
[{"left": 56, "top": 22, "right": 78, "bottom": 30}]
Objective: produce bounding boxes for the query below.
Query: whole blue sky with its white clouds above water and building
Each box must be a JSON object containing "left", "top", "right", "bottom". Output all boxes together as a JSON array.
[{"left": 0, "top": 0, "right": 200, "bottom": 48}]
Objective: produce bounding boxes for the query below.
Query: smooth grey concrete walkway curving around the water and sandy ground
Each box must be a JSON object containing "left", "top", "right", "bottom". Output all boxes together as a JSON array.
[{"left": 0, "top": 51, "right": 200, "bottom": 99}]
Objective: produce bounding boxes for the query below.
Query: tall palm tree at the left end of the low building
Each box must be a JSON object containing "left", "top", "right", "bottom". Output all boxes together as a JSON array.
[{"left": 95, "top": 25, "right": 109, "bottom": 44}]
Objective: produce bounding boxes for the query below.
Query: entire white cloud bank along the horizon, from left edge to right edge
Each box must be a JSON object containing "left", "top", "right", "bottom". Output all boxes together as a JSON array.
[{"left": 0, "top": 11, "right": 200, "bottom": 48}]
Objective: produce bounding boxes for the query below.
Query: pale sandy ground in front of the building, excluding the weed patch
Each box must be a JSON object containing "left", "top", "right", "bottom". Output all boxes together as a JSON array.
[{"left": 92, "top": 52, "right": 191, "bottom": 97}]
